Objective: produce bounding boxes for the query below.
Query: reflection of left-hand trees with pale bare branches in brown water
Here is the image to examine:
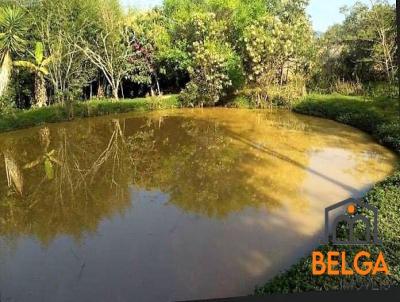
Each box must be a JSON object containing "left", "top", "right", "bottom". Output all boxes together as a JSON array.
[{"left": 0, "top": 121, "right": 130, "bottom": 242}]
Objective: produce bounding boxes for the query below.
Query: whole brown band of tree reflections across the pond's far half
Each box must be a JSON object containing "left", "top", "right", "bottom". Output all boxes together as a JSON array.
[{"left": 0, "top": 111, "right": 390, "bottom": 243}]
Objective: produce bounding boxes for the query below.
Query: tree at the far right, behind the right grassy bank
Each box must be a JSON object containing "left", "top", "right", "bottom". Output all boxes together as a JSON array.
[{"left": 316, "top": 1, "right": 397, "bottom": 85}]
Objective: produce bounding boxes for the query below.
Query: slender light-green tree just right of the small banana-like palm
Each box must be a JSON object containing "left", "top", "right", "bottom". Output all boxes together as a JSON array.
[{"left": 32, "top": 0, "right": 99, "bottom": 103}]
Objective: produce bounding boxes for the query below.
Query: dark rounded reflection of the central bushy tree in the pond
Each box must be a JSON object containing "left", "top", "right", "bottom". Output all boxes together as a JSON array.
[{"left": 133, "top": 119, "right": 278, "bottom": 217}]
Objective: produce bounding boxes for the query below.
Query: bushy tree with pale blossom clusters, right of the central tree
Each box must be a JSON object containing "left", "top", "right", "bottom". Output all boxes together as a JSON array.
[{"left": 243, "top": 3, "right": 313, "bottom": 85}]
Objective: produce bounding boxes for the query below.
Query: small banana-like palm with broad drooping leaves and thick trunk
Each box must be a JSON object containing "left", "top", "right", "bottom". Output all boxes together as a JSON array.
[{"left": 14, "top": 42, "right": 51, "bottom": 107}]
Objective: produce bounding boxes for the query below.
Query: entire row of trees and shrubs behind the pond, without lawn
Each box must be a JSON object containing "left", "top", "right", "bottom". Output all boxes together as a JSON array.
[{"left": 0, "top": 0, "right": 398, "bottom": 111}]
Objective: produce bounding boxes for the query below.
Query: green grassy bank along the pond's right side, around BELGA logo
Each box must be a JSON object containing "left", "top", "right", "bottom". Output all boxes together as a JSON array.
[{"left": 255, "top": 95, "right": 400, "bottom": 295}]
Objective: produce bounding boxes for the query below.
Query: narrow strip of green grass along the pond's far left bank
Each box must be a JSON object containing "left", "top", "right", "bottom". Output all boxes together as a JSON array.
[{"left": 0, "top": 95, "right": 178, "bottom": 132}]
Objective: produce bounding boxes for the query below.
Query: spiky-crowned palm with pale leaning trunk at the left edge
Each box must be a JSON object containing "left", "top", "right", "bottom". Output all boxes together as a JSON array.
[{"left": 0, "top": 7, "right": 28, "bottom": 96}]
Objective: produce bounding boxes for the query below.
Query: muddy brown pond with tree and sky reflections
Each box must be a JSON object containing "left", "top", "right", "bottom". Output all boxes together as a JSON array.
[{"left": 0, "top": 109, "right": 397, "bottom": 301}]
